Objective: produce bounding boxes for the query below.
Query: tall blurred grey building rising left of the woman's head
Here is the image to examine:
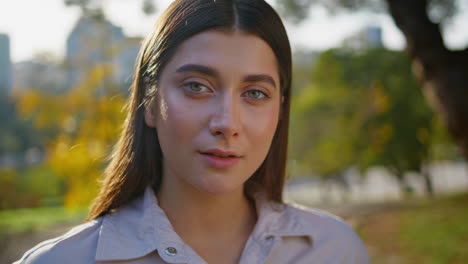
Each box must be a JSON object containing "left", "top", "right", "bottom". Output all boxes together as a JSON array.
[{"left": 65, "top": 12, "right": 141, "bottom": 92}]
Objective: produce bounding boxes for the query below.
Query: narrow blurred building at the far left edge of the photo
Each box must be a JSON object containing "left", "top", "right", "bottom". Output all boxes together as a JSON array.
[{"left": 0, "top": 34, "right": 12, "bottom": 94}]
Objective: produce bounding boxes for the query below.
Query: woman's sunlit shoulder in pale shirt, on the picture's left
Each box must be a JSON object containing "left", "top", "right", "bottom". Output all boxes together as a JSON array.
[{"left": 13, "top": 218, "right": 102, "bottom": 264}]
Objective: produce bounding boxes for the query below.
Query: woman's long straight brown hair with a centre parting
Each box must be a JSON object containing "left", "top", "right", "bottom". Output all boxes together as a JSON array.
[{"left": 87, "top": 0, "right": 291, "bottom": 221}]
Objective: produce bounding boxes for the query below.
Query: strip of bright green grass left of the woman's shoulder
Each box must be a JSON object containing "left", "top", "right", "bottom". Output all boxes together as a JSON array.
[{"left": 0, "top": 207, "right": 87, "bottom": 235}]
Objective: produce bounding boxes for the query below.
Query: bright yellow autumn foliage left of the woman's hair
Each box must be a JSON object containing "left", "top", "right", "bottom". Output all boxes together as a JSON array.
[{"left": 19, "top": 64, "right": 124, "bottom": 206}]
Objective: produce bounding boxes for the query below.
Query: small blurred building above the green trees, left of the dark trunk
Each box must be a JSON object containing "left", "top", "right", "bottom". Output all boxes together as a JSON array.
[{"left": 343, "top": 26, "right": 383, "bottom": 49}]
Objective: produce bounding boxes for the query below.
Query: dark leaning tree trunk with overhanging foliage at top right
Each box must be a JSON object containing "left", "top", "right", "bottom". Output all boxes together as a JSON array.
[{"left": 276, "top": 0, "right": 468, "bottom": 158}]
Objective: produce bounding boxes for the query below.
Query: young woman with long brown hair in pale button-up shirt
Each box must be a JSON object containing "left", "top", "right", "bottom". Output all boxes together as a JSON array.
[{"left": 17, "top": 0, "right": 369, "bottom": 264}]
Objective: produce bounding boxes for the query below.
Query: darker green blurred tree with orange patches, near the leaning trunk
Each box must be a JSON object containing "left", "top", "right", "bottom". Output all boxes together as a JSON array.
[{"left": 351, "top": 49, "right": 433, "bottom": 194}]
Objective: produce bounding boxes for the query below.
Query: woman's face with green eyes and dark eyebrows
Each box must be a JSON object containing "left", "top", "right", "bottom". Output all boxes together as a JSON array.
[{"left": 145, "top": 30, "right": 281, "bottom": 195}]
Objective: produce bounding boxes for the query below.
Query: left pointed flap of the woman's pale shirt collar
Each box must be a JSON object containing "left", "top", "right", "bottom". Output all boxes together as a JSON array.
[{"left": 95, "top": 187, "right": 196, "bottom": 263}]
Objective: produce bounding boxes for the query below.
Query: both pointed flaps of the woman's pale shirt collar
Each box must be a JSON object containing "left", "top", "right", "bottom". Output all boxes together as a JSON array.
[{"left": 95, "top": 186, "right": 313, "bottom": 263}]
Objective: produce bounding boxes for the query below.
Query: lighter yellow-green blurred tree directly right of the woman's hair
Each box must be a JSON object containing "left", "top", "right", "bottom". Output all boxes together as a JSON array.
[{"left": 290, "top": 51, "right": 358, "bottom": 177}]
